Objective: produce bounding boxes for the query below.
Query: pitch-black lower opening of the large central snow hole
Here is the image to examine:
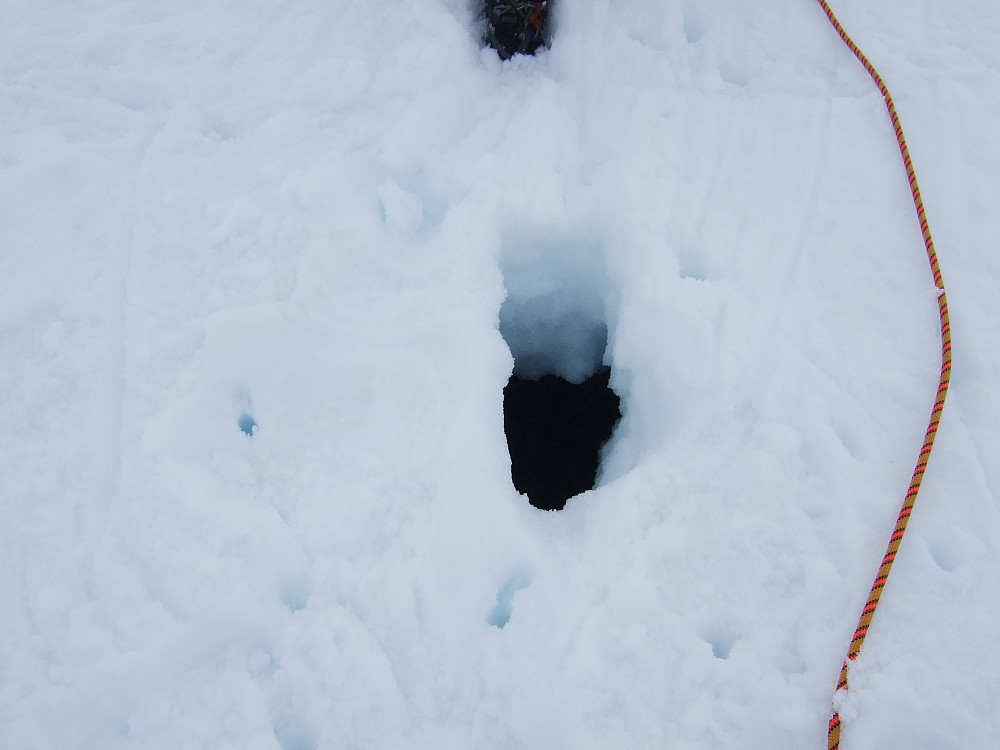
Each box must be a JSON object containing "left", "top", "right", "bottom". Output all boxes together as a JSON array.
[{"left": 503, "top": 367, "right": 621, "bottom": 510}]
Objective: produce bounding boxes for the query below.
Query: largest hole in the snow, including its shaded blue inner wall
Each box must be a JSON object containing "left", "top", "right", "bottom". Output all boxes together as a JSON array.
[{"left": 500, "top": 238, "right": 621, "bottom": 510}]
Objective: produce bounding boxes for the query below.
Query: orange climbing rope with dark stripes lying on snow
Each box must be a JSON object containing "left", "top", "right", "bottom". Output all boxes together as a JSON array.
[{"left": 817, "top": 0, "right": 951, "bottom": 750}]
